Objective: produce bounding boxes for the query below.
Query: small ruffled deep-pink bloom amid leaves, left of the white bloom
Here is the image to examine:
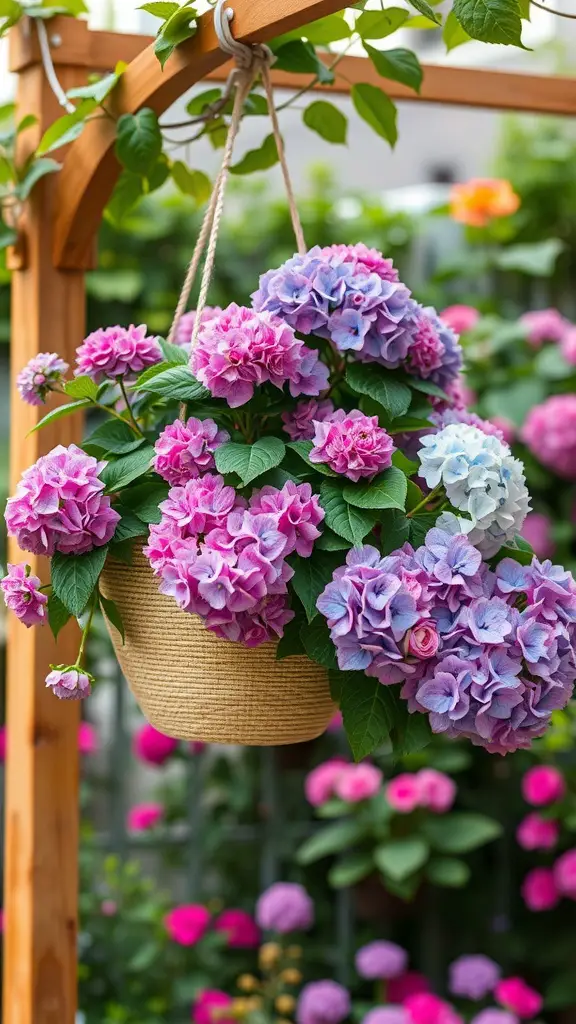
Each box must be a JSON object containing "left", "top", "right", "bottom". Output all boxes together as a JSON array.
[{"left": 310, "top": 409, "right": 395, "bottom": 482}]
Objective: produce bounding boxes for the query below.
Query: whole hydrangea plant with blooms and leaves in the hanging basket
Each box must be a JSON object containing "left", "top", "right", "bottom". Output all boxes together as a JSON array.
[{"left": 2, "top": 244, "right": 576, "bottom": 759}]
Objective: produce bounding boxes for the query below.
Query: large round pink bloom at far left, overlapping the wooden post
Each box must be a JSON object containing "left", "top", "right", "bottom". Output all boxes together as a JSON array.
[{"left": 5, "top": 444, "right": 120, "bottom": 555}]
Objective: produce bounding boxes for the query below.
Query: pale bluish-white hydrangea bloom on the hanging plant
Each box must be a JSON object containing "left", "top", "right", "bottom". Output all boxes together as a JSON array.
[{"left": 418, "top": 423, "right": 530, "bottom": 557}]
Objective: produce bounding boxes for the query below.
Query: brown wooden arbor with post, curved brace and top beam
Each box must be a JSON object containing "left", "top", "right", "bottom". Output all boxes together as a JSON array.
[{"left": 3, "top": 0, "right": 576, "bottom": 1024}]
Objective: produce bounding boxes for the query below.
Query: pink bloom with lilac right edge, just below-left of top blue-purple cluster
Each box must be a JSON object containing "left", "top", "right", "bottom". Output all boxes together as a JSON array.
[{"left": 191, "top": 302, "right": 328, "bottom": 409}]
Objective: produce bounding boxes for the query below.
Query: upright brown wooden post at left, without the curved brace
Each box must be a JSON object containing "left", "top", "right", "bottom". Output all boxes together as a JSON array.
[{"left": 3, "top": 22, "right": 93, "bottom": 1024}]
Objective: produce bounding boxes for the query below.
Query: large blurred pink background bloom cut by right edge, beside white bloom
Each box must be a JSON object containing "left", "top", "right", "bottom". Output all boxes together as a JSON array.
[{"left": 521, "top": 394, "right": 576, "bottom": 480}]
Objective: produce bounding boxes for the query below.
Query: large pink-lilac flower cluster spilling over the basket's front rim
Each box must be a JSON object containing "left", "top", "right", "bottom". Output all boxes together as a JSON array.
[{"left": 145, "top": 473, "right": 324, "bottom": 647}]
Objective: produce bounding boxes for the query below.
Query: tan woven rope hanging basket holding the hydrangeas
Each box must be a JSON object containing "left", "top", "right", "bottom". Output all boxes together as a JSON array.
[{"left": 100, "top": 549, "right": 335, "bottom": 746}]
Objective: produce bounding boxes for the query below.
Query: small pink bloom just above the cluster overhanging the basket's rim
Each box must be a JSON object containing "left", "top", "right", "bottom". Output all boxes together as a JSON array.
[{"left": 154, "top": 416, "right": 230, "bottom": 486}]
